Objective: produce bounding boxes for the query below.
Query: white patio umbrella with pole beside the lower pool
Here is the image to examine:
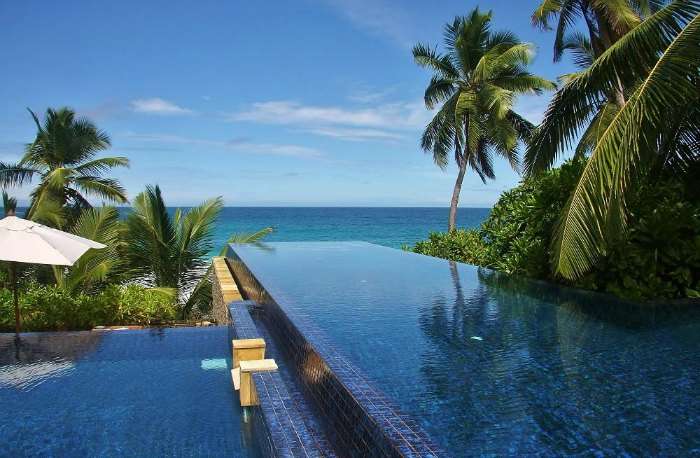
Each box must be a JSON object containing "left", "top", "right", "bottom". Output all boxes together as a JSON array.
[{"left": 0, "top": 214, "right": 105, "bottom": 334}]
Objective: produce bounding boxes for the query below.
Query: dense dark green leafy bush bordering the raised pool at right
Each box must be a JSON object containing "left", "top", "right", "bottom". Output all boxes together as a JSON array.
[{"left": 413, "top": 161, "right": 700, "bottom": 299}]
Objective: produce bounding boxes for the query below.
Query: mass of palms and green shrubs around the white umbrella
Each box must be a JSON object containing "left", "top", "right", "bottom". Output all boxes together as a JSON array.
[{"left": 0, "top": 108, "right": 272, "bottom": 330}]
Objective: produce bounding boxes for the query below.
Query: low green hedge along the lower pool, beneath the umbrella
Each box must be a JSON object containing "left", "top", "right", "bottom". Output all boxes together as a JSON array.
[{"left": 0, "top": 284, "right": 177, "bottom": 331}]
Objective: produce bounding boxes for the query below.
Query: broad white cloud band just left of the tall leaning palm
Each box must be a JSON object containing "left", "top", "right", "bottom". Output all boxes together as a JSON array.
[{"left": 229, "top": 100, "right": 430, "bottom": 130}]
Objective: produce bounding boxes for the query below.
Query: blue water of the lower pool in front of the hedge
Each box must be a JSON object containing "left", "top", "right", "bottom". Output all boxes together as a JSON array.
[{"left": 0, "top": 327, "right": 257, "bottom": 457}]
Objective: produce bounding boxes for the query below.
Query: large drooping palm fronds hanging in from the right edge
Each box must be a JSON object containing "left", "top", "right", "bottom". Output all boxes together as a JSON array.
[{"left": 526, "top": 0, "right": 700, "bottom": 279}]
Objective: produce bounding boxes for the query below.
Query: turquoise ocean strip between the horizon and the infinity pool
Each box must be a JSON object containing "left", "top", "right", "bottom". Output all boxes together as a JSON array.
[{"left": 214, "top": 207, "right": 490, "bottom": 249}]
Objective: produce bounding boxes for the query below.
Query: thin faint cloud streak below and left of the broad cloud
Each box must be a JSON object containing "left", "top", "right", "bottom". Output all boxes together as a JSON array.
[{"left": 124, "top": 133, "right": 323, "bottom": 159}]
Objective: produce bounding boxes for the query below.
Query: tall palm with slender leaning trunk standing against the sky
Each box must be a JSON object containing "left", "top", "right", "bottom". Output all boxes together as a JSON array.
[{"left": 413, "top": 8, "right": 554, "bottom": 231}]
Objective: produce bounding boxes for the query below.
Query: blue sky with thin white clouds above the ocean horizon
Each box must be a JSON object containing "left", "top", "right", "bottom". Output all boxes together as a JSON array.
[{"left": 0, "top": 0, "right": 573, "bottom": 207}]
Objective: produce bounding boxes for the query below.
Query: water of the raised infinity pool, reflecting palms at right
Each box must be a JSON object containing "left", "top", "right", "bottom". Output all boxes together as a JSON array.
[{"left": 234, "top": 242, "right": 700, "bottom": 456}]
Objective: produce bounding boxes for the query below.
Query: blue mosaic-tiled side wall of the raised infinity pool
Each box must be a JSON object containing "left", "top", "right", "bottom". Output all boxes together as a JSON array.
[{"left": 227, "top": 247, "right": 443, "bottom": 457}]
